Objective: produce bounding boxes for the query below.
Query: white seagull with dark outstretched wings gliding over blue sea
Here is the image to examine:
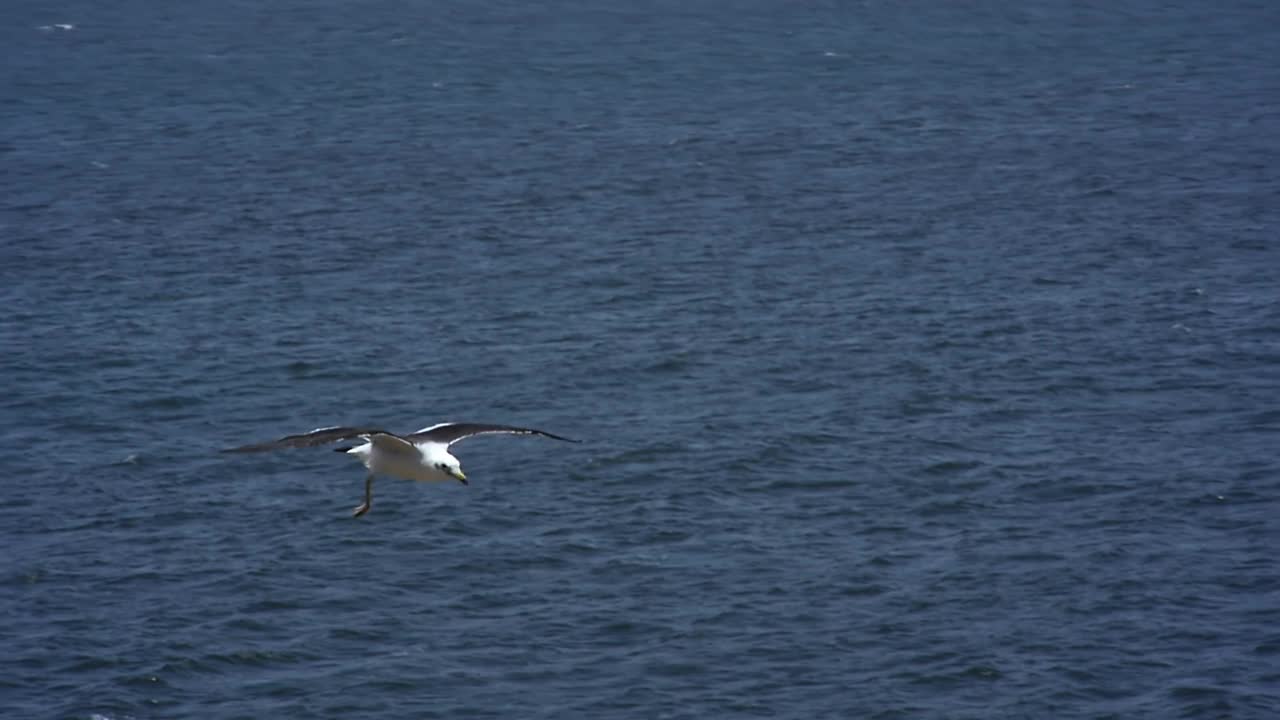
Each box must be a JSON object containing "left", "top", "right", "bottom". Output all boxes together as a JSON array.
[{"left": 223, "top": 423, "right": 579, "bottom": 518}]
